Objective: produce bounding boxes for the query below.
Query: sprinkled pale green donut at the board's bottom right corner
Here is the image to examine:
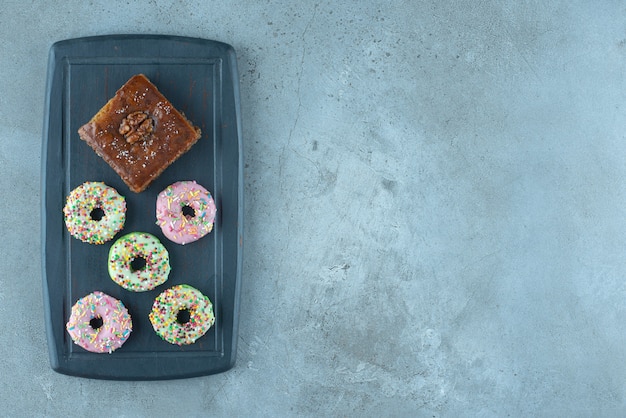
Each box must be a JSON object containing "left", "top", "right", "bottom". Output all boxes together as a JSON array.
[{"left": 149, "top": 284, "right": 215, "bottom": 345}]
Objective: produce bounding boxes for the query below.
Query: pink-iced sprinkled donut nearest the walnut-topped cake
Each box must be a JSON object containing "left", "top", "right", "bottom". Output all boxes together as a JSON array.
[{"left": 156, "top": 181, "right": 216, "bottom": 245}]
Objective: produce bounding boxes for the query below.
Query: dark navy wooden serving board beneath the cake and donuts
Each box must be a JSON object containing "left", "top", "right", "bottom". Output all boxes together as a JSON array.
[{"left": 42, "top": 35, "right": 243, "bottom": 380}]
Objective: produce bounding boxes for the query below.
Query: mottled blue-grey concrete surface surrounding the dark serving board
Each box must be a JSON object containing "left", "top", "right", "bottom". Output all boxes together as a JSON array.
[{"left": 0, "top": 0, "right": 626, "bottom": 417}]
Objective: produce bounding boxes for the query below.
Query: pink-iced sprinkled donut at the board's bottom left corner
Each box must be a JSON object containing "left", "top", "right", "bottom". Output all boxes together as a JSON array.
[{"left": 65, "top": 291, "right": 133, "bottom": 353}]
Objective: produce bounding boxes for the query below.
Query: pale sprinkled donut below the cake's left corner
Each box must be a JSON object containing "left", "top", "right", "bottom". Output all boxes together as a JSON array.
[{"left": 63, "top": 181, "right": 126, "bottom": 244}]
